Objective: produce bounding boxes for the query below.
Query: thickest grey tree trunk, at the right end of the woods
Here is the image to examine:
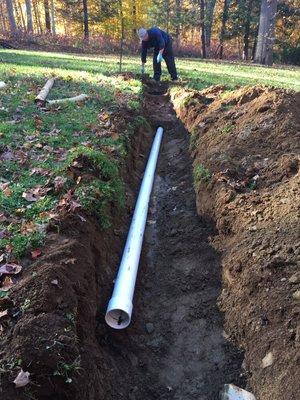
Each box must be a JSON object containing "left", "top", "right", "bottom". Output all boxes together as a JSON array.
[{"left": 255, "top": 0, "right": 277, "bottom": 65}]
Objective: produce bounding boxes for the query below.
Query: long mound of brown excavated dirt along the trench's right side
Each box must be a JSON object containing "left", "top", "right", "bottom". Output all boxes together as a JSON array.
[{"left": 171, "top": 86, "right": 300, "bottom": 400}]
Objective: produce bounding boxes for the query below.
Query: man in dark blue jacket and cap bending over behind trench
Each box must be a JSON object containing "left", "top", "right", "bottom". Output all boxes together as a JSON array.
[{"left": 138, "top": 27, "right": 178, "bottom": 81}]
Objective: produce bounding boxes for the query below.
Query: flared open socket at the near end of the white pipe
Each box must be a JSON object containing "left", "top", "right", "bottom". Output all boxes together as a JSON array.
[{"left": 105, "top": 297, "right": 133, "bottom": 329}]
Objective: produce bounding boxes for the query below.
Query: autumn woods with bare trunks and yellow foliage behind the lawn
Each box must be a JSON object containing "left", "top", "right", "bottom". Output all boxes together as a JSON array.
[{"left": 0, "top": 0, "right": 300, "bottom": 65}]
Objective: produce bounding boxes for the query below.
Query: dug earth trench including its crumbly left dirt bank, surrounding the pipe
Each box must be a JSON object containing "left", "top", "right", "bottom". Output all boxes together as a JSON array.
[{"left": 0, "top": 82, "right": 245, "bottom": 400}]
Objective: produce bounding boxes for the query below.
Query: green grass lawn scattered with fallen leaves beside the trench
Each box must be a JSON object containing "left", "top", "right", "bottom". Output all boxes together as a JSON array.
[{"left": 0, "top": 50, "right": 300, "bottom": 259}]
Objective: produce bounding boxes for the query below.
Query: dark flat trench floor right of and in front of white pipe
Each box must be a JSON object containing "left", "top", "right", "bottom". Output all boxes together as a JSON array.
[{"left": 98, "top": 82, "right": 244, "bottom": 400}]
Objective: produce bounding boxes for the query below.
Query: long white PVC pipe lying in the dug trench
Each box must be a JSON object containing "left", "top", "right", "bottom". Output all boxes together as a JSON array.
[{"left": 105, "top": 127, "right": 163, "bottom": 329}]
